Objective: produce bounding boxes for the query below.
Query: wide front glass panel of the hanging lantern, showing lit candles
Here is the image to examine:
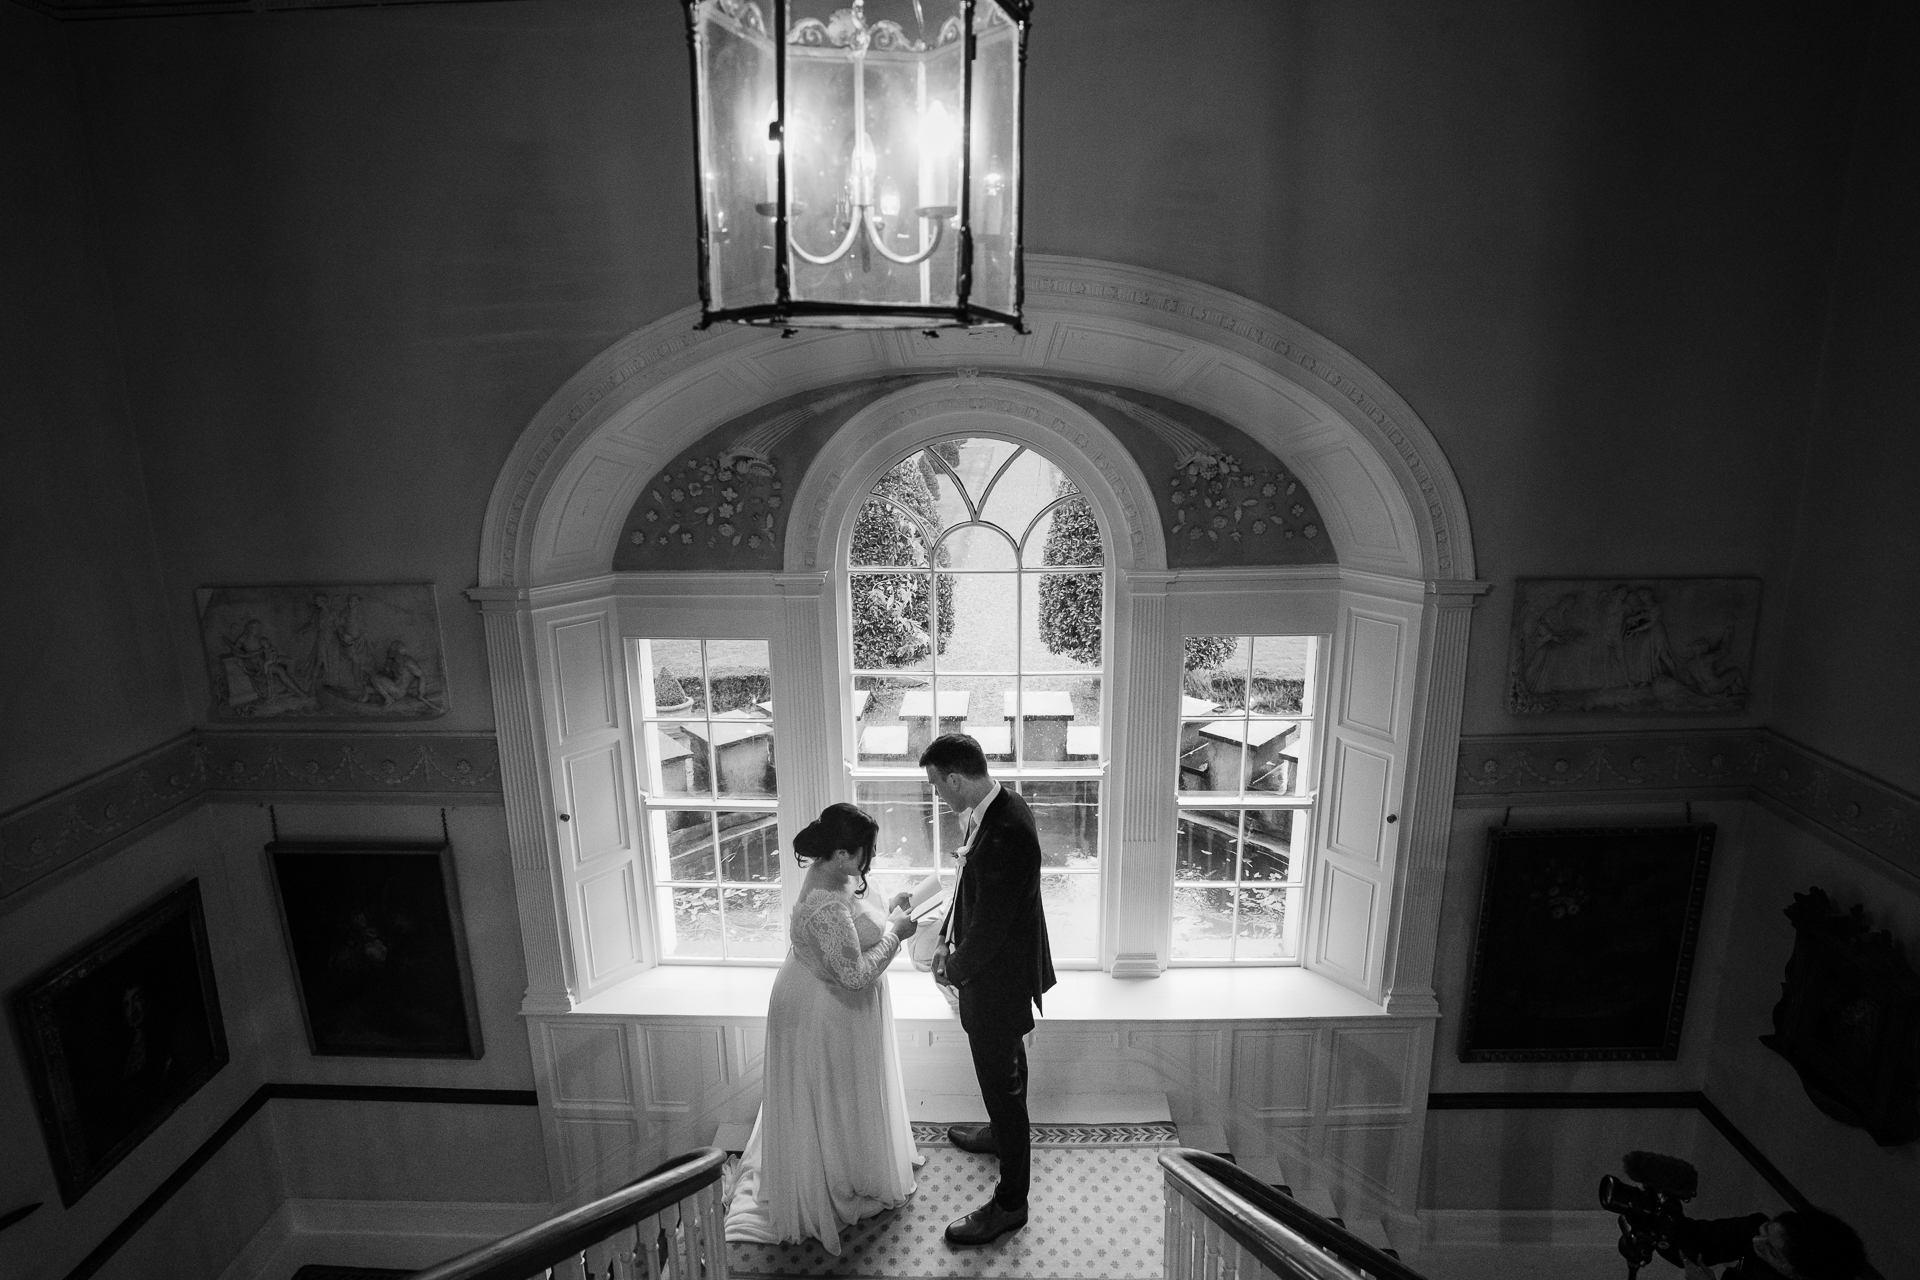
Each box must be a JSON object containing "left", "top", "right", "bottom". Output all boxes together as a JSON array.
[{"left": 785, "top": 0, "right": 966, "bottom": 324}]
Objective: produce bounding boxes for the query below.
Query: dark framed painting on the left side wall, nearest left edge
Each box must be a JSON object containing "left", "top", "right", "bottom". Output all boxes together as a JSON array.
[{"left": 13, "top": 881, "right": 227, "bottom": 1205}]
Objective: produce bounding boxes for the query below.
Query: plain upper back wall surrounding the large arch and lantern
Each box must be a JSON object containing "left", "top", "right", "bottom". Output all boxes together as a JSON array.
[{"left": 48, "top": 0, "right": 1859, "bottom": 752}]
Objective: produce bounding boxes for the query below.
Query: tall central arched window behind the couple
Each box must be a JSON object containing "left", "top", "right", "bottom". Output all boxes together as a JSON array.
[{"left": 843, "top": 436, "right": 1108, "bottom": 965}]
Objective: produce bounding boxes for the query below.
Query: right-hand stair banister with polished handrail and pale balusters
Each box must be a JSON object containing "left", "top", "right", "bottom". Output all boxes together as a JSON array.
[{"left": 1160, "top": 1148, "right": 1425, "bottom": 1280}]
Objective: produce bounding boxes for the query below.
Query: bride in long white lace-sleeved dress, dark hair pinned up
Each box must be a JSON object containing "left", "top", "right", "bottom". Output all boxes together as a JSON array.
[{"left": 726, "top": 804, "right": 918, "bottom": 1255}]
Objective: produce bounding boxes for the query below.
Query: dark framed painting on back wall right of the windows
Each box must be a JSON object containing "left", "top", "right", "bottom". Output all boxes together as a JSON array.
[{"left": 1459, "top": 823, "right": 1715, "bottom": 1063}]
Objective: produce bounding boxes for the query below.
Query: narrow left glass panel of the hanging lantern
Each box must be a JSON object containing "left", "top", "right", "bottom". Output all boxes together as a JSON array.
[{"left": 691, "top": 0, "right": 780, "bottom": 311}]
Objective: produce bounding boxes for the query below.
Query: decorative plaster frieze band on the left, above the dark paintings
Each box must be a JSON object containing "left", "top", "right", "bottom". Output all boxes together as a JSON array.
[{"left": 0, "top": 731, "right": 501, "bottom": 900}]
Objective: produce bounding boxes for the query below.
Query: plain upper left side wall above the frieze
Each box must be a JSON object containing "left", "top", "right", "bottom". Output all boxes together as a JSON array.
[{"left": 0, "top": 6, "right": 188, "bottom": 812}]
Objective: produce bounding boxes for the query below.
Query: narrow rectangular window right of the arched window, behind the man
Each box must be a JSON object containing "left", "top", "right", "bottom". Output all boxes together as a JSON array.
[{"left": 1171, "top": 635, "right": 1319, "bottom": 963}]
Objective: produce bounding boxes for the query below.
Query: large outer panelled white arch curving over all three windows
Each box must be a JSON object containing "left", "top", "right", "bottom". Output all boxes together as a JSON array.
[{"left": 480, "top": 255, "right": 1475, "bottom": 587}]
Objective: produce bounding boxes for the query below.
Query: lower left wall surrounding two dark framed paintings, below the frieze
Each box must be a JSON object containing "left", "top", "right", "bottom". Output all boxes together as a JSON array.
[{"left": 0, "top": 804, "right": 549, "bottom": 1280}]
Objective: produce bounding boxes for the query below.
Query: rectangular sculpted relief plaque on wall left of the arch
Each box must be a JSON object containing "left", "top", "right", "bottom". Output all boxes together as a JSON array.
[{"left": 198, "top": 581, "right": 447, "bottom": 722}]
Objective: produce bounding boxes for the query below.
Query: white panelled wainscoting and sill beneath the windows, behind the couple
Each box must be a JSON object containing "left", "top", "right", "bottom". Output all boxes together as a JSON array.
[{"left": 528, "top": 969, "right": 1432, "bottom": 1215}]
